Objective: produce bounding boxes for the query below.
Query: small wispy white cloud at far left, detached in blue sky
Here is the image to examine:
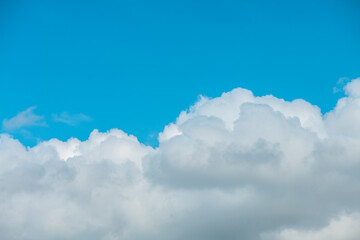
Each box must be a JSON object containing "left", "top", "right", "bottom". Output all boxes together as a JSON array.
[{"left": 2, "top": 106, "right": 46, "bottom": 131}]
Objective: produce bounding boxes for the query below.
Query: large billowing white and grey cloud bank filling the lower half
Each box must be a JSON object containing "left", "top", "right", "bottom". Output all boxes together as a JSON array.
[{"left": 0, "top": 79, "right": 360, "bottom": 240}]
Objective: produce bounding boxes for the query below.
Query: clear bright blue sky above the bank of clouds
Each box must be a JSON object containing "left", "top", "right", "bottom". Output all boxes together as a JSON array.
[{"left": 0, "top": 0, "right": 360, "bottom": 145}]
